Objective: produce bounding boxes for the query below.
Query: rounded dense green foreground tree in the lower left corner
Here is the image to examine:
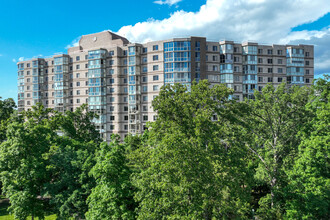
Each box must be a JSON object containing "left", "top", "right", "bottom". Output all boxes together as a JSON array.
[{"left": 0, "top": 105, "right": 55, "bottom": 219}]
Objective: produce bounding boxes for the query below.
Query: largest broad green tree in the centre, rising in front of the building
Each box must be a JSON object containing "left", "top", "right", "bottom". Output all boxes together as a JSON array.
[{"left": 133, "top": 81, "right": 248, "bottom": 219}]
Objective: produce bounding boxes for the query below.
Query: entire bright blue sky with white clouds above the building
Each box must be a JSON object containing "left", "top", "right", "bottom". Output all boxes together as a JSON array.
[{"left": 0, "top": 0, "right": 330, "bottom": 100}]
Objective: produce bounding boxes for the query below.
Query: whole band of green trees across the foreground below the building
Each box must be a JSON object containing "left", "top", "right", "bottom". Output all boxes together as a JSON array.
[{"left": 0, "top": 77, "right": 330, "bottom": 220}]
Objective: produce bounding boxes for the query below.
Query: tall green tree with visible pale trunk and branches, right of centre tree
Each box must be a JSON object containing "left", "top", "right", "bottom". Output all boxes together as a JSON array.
[{"left": 236, "top": 84, "right": 313, "bottom": 218}]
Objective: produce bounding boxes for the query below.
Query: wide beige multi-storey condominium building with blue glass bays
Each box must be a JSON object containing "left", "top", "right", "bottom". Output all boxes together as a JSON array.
[{"left": 18, "top": 31, "right": 314, "bottom": 141}]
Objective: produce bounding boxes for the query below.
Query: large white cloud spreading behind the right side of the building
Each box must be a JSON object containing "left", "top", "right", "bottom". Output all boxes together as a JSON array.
[{"left": 117, "top": 0, "right": 330, "bottom": 72}]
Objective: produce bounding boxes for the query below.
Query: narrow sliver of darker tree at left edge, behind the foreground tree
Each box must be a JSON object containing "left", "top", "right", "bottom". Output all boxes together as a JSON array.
[{"left": 0, "top": 97, "right": 16, "bottom": 143}]
